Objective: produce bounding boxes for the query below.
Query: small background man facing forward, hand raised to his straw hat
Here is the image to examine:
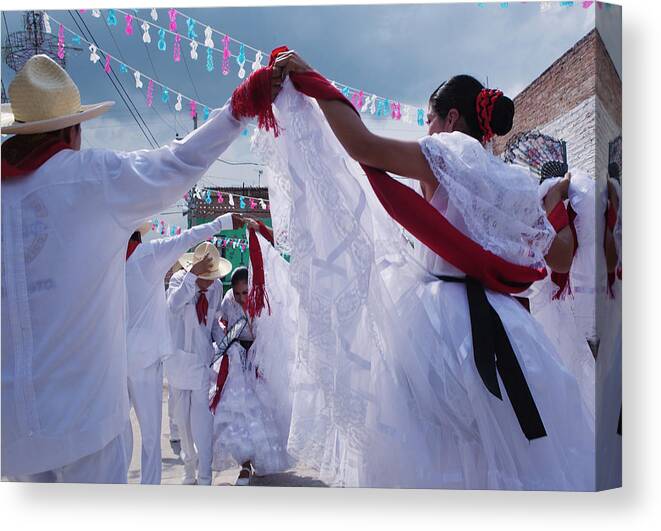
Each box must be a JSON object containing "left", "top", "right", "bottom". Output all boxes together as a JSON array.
[{"left": 165, "top": 242, "right": 232, "bottom": 485}]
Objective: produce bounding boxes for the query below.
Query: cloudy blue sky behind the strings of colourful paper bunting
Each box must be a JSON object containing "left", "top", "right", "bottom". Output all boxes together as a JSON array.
[{"left": 2, "top": 2, "right": 621, "bottom": 227}]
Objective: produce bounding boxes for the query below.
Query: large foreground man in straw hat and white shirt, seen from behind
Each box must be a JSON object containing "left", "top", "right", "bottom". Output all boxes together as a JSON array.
[{"left": 1, "top": 55, "right": 250, "bottom": 483}]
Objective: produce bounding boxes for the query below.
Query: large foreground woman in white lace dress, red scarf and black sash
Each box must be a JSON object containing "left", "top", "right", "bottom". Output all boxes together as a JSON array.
[{"left": 227, "top": 52, "right": 594, "bottom": 490}]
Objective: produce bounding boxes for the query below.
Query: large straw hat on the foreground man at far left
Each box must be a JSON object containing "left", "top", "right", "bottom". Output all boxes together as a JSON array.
[{"left": 0, "top": 55, "right": 115, "bottom": 135}]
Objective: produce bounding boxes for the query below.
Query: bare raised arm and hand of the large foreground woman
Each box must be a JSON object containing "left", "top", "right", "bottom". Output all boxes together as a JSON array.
[{"left": 274, "top": 52, "right": 437, "bottom": 188}]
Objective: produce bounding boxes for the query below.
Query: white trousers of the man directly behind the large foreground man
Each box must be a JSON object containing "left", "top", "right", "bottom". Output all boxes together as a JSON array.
[{"left": 128, "top": 360, "right": 163, "bottom": 485}]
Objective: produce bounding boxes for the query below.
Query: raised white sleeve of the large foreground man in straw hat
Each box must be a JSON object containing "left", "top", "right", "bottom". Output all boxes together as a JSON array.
[{"left": 92, "top": 103, "right": 243, "bottom": 230}]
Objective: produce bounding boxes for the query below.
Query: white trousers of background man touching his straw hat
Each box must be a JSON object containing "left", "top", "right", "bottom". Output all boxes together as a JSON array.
[{"left": 170, "top": 386, "right": 213, "bottom": 485}]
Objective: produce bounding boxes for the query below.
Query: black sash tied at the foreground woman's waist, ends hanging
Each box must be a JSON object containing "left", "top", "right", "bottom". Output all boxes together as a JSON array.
[{"left": 437, "top": 275, "right": 546, "bottom": 440}]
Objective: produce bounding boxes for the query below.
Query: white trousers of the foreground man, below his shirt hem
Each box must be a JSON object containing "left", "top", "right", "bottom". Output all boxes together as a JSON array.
[{"left": 9, "top": 433, "right": 129, "bottom": 483}]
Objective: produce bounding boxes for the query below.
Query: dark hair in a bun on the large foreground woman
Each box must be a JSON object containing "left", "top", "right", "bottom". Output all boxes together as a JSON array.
[{"left": 429, "top": 74, "right": 514, "bottom": 141}]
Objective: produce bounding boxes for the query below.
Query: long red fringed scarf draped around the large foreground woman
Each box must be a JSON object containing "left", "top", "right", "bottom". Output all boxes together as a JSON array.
[{"left": 232, "top": 46, "right": 546, "bottom": 293}]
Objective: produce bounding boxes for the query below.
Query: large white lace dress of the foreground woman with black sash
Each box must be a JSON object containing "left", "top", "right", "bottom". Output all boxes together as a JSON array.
[{"left": 251, "top": 82, "right": 594, "bottom": 490}]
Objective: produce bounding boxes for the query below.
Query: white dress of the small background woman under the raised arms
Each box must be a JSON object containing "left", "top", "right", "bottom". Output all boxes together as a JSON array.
[{"left": 213, "top": 290, "right": 287, "bottom": 475}]
